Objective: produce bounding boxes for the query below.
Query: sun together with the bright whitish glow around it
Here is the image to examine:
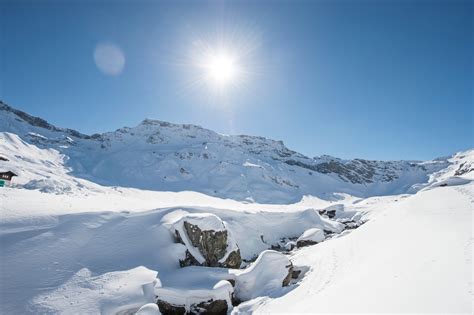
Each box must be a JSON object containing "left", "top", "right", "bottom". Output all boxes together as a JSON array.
[{"left": 178, "top": 22, "right": 262, "bottom": 103}]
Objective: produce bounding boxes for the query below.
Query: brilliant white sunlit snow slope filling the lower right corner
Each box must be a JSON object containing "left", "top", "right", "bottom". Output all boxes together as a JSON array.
[{"left": 241, "top": 184, "right": 474, "bottom": 314}]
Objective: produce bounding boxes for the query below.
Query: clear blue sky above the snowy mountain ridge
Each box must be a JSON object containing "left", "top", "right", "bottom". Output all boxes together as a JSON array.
[{"left": 0, "top": 0, "right": 474, "bottom": 159}]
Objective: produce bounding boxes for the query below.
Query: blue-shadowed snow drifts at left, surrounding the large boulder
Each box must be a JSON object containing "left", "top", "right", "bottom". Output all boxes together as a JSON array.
[{"left": 0, "top": 204, "right": 341, "bottom": 314}]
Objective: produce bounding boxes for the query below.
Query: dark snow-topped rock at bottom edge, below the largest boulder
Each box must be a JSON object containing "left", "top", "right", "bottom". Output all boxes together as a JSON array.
[{"left": 155, "top": 280, "right": 234, "bottom": 315}]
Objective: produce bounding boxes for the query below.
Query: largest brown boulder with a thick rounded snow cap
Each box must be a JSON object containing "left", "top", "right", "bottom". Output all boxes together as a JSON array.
[{"left": 168, "top": 213, "right": 242, "bottom": 268}]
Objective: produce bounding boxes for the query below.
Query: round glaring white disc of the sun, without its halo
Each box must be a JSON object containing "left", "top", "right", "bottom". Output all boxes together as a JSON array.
[{"left": 204, "top": 52, "right": 239, "bottom": 87}]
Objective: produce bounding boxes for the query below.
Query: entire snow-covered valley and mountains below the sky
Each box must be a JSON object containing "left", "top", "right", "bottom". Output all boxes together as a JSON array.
[{"left": 0, "top": 103, "right": 474, "bottom": 314}]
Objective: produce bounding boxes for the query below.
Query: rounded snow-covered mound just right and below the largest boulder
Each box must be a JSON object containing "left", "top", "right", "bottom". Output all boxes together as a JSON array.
[{"left": 233, "top": 250, "right": 293, "bottom": 301}]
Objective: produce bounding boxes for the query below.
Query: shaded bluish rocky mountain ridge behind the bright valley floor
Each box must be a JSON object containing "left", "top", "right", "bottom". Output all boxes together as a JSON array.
[{"left": 0, "top": 102, "right": 452, "bottom": 203}]
